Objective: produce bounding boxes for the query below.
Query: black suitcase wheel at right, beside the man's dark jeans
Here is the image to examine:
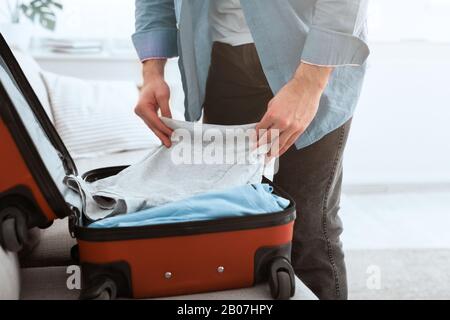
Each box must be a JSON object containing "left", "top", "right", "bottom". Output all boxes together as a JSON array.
[{"left": 269, "top": 258, "right": 295, "bottom": 300}]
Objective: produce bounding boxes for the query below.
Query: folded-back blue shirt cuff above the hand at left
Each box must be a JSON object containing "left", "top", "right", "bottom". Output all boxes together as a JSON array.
[{"left": 132, "top": 29, "right": 178, "bottom": 61}]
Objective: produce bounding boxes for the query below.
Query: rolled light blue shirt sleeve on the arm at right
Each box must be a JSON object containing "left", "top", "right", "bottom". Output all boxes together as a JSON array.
[{"left": 302, "top": 0, "right": 370, "bottom": 67}]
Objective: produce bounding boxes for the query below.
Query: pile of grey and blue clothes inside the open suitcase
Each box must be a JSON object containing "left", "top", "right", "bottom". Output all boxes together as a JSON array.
[{"left": 66, "top": 119, "right": 289, "bottom": 228}]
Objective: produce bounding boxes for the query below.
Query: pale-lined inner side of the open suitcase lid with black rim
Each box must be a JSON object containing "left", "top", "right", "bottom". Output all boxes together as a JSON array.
[{"left": 0, "top": 33, "right": 79, "bottom": 217}]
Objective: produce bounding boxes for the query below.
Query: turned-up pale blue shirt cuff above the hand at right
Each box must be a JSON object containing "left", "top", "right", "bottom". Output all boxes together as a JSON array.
[{"left": 302, "top": 27, "right": 370, "bottom": 67}]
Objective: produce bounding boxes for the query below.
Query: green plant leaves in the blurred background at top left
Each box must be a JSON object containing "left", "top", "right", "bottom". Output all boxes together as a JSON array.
[{"left": 8, "top": 0, "right": 63, "bottom": 30}]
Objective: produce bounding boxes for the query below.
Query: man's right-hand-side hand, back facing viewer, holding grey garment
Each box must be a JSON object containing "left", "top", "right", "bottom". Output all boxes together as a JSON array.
[{"left": 256, "top": 63, "right": 333, "bottom": 160}]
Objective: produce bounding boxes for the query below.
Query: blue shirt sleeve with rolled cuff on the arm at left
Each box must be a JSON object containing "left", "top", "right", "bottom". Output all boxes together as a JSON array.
[{"left": 132, "top": 0, "right": 178, "bottom": 61}]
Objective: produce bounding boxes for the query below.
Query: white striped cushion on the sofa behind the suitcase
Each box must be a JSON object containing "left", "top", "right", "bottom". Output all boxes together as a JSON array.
[{"left": 42, "top": 72, "right": 159, "bottom": 157}]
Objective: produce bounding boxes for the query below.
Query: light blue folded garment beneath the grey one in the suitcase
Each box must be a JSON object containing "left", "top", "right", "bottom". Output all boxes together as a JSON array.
[{"left": 89, "top": 183, "right": 289, "bottom": 228}]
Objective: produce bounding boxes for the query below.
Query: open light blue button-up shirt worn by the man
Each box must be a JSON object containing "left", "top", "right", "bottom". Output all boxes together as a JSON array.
[{"left": 132, "top": 0, "right": 369, "bottom": 148}]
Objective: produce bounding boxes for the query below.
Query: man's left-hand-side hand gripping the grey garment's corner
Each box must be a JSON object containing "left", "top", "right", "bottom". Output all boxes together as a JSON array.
[{"left": 134, "top": 59, "right": 173, "bottom": 147}]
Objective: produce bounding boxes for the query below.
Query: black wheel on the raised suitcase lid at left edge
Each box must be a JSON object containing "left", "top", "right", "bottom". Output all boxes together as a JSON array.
[{"left": 0, "top": 207, "right": 28, "bottom": 252}]
